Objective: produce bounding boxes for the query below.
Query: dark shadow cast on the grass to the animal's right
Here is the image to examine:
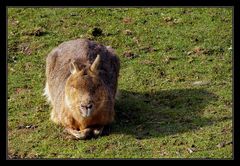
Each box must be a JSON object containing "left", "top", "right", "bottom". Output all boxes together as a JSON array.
[{"left": 111, "top": 89, "right": 220, "bottom": 139}]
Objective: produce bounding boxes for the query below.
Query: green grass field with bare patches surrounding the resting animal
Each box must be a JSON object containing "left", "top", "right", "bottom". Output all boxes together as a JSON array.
[{"left": 8, "top": 8, "right": 233, "bottom": 158}]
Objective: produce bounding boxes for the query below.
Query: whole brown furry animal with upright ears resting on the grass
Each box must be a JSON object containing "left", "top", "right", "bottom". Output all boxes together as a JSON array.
[{"left": 45, "top": 39, "right": 120, "bottom": 138}]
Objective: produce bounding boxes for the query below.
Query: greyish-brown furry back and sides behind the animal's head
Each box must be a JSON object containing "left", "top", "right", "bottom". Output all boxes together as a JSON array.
[{"left": 46, "top": 39, "right": 120, "bottom": 109}]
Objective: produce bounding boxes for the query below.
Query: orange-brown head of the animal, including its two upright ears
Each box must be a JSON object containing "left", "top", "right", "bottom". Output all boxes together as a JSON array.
[{"left": 65, "top": 55, "right": 107, "bottom": 118}]
